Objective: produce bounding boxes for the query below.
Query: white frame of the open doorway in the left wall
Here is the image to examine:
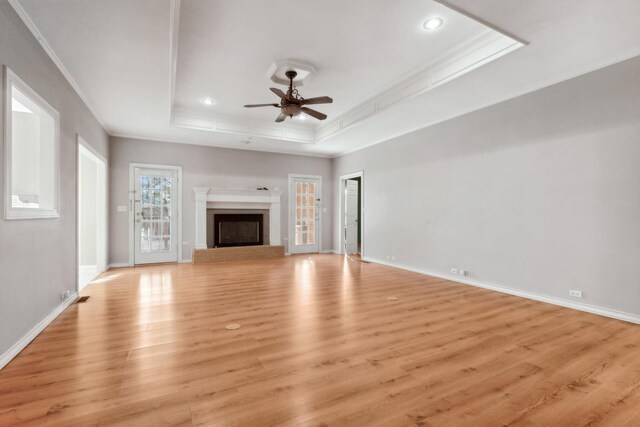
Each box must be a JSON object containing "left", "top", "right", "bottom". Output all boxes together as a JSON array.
[{"left": 75, "top": 134, "right": 109, "bottom": 292}]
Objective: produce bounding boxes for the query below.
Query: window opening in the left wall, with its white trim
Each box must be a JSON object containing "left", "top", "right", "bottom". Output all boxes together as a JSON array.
[{"left": 4, "top": 67, "right": 60, "bottom": 219}]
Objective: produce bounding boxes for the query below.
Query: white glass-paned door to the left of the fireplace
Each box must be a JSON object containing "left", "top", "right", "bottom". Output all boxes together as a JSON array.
[{"left": 134, "top": 167, "right": 178, "bottom": 264}]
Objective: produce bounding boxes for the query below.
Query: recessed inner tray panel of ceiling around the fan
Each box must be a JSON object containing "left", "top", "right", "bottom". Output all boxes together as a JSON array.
[{"left": 175, "top": 0, "right": 484, "bottom": 121}]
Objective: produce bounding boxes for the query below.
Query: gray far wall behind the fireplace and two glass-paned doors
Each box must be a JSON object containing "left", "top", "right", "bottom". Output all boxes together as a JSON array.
[{"left": 109, "top": 137, "right": 333, "bottom": 264}]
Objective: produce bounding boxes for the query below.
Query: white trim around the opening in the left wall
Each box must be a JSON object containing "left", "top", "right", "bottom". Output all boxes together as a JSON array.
[{"left": 4, "top": 65, "right": 60, "bottom": 219}]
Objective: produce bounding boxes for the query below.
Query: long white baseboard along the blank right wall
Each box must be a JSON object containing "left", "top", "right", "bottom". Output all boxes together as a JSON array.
[{"left": 363, "top": 257, "right": 640, "bottom": 324}]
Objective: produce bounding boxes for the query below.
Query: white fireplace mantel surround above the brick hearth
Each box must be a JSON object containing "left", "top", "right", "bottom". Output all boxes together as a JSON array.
[{"left": 193, "top": 187, "right": 282, "bottom": 249}]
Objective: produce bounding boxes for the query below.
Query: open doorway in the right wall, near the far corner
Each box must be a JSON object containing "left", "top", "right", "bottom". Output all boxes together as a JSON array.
[{"left": 339, "top": 171, "right": 364, "bottom": 256}]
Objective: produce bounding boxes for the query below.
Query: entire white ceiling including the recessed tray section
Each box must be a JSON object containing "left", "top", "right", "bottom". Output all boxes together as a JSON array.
[{"left": 10, "top": 0, "right": 640, "bottom": 156}]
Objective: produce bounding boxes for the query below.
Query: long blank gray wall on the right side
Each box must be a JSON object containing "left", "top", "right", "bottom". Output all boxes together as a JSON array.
[{"left": 334, "top": 57, "right": 640, "bottom": 314}]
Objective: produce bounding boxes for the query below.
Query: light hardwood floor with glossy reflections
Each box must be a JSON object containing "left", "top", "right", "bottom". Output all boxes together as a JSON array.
[{"left": 0, "top": 255, "right": 640, "bottom": 426}]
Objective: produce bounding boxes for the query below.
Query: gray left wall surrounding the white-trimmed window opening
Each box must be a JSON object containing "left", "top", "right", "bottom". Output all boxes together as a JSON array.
[{"left": 0, "top": 1, "right": 109, "bottom": 355}]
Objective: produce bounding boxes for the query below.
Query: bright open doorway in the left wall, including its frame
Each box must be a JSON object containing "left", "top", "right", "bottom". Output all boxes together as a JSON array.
[{"left": 78, "top": 136, "right": 107, "bottom": 292}]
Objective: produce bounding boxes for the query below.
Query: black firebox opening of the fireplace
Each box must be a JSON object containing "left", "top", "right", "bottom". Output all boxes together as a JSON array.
[{"left": 213, "top": 213, "right": 264, "bottom": 248}]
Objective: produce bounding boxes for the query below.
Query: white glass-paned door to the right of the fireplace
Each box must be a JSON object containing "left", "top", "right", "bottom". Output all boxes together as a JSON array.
[{"left": 289, "top": 177, "right": 321, "bottom": 253}]
